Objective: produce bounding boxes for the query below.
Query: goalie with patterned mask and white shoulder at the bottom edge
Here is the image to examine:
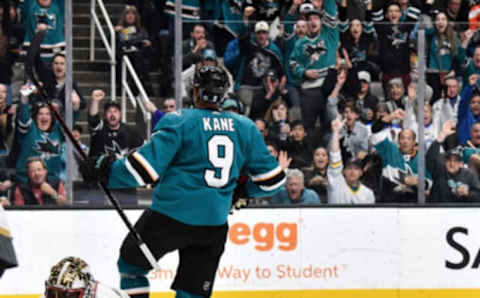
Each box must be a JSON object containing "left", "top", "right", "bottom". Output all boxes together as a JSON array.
[{"left": 42, "top": 257, "right": 129, "bottom": 298}]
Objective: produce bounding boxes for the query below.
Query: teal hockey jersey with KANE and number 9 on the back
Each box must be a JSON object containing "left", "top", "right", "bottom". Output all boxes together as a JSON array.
[{"left": 108, "top": 109, "right": 286, "bottom": 226}]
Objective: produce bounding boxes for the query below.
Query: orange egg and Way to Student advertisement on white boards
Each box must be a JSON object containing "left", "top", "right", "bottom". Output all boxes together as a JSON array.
[{"left": 148, "top": 215, "right": 345, "bottom": 285}]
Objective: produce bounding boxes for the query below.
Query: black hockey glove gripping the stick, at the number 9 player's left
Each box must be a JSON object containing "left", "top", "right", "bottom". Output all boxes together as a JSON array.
[{"left": 79, "top": 154, "right": 117, "bottom": 185}]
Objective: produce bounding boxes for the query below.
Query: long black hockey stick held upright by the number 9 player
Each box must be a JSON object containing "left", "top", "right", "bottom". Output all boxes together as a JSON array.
[{"left": 25, "top": 30, "right": 160, "bottom": 271}]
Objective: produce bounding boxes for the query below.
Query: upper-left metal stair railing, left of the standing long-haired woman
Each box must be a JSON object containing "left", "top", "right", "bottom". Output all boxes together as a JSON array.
[{"left": 90, "top": 0, "right": 117, "bottom": 100}]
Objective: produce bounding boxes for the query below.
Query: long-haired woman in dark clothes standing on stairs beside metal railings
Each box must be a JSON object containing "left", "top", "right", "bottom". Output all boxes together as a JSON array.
[{"left": 115, "top": 5, "right": 152, "bottom": 96}]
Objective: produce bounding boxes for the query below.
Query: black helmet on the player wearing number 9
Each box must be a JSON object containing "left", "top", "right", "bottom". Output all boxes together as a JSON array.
[{"left": 194, "top": 65, "right": 229, "bottom": 104}]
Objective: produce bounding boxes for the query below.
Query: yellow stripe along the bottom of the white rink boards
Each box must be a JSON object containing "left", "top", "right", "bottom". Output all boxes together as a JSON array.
[{"left": 4, "top": 289, "right": 480, "bottom": 298}]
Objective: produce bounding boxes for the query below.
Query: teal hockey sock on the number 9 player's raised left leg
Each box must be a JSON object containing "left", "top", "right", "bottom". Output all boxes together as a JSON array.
[{"left": 117, "top": 257, "right": 150, "bottom": 298}]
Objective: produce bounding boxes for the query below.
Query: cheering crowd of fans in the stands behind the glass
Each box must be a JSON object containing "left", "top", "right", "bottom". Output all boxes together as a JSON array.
[{"left": 0, "top": 0, "right": 480, "bottom": 205}]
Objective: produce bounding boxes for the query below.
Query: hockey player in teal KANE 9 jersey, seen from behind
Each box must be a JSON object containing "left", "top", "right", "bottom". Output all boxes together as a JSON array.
[{"left": 82, "top": 66, "right": 285, "bottom": 298}]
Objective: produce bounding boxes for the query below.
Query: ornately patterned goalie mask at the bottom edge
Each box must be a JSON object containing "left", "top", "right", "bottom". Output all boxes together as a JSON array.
[{"left": 45, "top": 257, "right": 95, "bottom": 298}]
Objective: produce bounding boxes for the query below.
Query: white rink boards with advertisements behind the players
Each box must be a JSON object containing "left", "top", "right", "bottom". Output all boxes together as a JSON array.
[{"left": 0, "top": 208, "right": 480, "bottom": 298}]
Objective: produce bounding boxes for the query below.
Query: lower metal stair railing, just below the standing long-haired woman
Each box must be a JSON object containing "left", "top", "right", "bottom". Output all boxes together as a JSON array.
[{"left": 121, "top": 55, "right": 152, "bottom": 141}]
